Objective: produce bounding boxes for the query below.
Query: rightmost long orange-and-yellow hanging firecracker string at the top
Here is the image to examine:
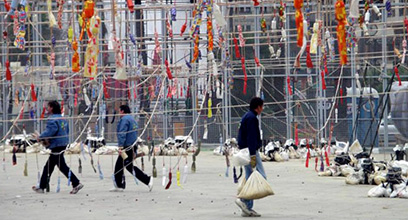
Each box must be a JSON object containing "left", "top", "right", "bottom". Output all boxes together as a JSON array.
[{"left": 335, "top": 0, "right": 347, "bottom": 65}]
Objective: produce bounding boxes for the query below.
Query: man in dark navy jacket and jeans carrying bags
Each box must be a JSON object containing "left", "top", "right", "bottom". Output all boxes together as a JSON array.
[{"left": 235, "top": 97, "right": 266, "bottom": 217}]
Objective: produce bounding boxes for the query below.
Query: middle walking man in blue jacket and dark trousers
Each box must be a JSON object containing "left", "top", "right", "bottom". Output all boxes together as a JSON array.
[{"left": 110, "top": 105, "right": 153, "bottom": 192}]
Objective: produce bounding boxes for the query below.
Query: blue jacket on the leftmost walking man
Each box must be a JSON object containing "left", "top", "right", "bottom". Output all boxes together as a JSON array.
[{"left": 39, "top": 114, "right": 69, "bottom": 149}]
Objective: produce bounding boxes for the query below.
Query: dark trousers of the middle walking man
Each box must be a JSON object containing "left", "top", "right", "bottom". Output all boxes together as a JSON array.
[{"left": 115, "top": 147, "right": 150, "bottom": 189}]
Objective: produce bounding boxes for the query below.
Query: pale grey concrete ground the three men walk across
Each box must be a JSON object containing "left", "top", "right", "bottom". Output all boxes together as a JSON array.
[{"left": 0, "top": 151, "right": 408, "bottom": 220}]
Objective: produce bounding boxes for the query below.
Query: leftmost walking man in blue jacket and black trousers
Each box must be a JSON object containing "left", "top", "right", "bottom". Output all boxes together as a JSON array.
[{"left": 32, "top": 101, "right": 84, "bottom": 194}]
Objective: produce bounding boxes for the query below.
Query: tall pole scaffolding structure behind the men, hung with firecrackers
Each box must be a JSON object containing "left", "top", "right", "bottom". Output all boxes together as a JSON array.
[{"left": 0, "top": 0, "right": 408, "bottom": 150}]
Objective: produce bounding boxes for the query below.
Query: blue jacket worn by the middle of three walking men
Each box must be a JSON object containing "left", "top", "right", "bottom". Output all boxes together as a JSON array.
[{"left": 117, "top": 115, "right": 137, "bottom": 147}]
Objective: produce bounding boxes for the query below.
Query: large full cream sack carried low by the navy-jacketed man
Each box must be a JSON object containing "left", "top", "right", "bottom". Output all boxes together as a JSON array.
[{"left": 238, "top": 170, "right": 274, "bottom": 199}]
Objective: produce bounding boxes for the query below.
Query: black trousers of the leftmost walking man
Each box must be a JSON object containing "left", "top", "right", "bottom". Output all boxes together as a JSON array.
[{"left": 40, "top": 147, "right": 79, "bottom": 189}]
